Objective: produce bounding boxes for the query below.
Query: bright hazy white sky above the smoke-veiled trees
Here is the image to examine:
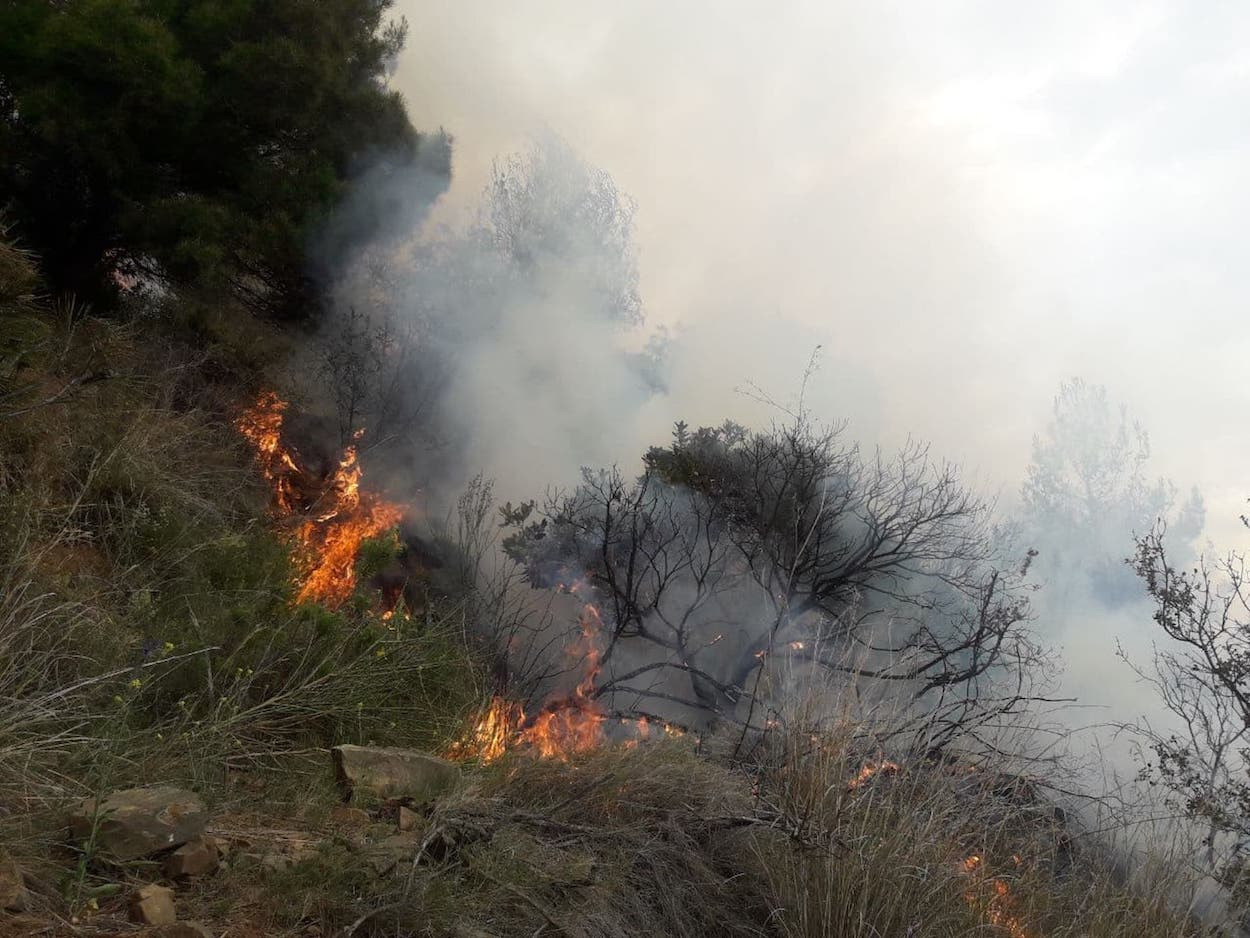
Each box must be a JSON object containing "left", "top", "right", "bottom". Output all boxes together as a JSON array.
[{"left": 395, "top": 0, "right": 1250, "bottom": 543}]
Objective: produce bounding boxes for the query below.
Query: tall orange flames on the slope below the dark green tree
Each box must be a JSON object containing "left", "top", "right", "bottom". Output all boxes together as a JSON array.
[{"left": 236, "top": 391, "right": 404, "bottom": 607}]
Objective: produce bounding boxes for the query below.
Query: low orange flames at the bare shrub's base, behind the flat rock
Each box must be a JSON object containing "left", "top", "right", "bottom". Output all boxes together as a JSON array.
[{"left": 446, "top": 602, "right": 684, "bottom": 762}]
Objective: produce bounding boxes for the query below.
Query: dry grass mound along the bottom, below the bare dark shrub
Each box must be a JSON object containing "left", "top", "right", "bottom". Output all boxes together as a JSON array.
[{"left": 210, "top": 737, "right": 1199, "bottom": 938}]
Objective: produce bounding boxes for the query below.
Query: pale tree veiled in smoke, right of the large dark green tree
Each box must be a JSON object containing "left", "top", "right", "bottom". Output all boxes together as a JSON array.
[{"left": 325, "top": 138, "right": 661, "bottom": 488}]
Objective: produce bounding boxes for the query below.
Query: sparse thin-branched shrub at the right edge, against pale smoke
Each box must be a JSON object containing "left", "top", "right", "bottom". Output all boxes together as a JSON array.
[{"left": 1133, "top": 525, "right": 1250, "bottom": 908}]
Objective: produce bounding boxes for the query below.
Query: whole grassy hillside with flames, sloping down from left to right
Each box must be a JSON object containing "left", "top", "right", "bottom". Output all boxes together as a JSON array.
[{"left": 0, "top": 233, "right": 1198, "bottom": 938}]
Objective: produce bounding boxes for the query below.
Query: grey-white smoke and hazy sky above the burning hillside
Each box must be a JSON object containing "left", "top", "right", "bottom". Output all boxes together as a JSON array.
[{"left": 312, "top": 7, "right": 1250, "bottom": 930}]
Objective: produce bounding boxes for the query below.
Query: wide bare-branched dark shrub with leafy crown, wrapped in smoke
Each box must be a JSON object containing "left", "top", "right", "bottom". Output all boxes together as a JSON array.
[{"left": 505, "top": 415, "right": 1041, "bottom": 747}]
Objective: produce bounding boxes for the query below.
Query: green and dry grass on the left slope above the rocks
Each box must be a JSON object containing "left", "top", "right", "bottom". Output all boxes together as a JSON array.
[{"left": 0, "top": 253, "right": 481, "bottom": 859}]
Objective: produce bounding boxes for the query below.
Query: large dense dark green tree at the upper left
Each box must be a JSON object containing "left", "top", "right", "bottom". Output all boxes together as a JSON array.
[{"left": 0, "top": 0, "right": 435, "bottom": 314}]
